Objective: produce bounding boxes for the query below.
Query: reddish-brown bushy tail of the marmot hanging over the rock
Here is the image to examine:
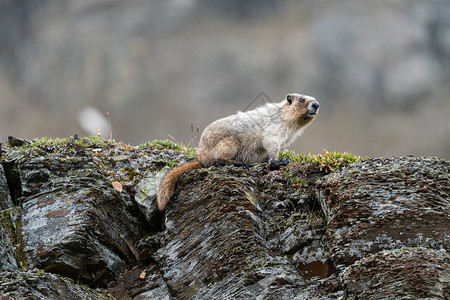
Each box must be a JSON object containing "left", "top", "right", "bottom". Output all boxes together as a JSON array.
[{"left": 156, "top": 161, "right": 203, "bottom": 211}]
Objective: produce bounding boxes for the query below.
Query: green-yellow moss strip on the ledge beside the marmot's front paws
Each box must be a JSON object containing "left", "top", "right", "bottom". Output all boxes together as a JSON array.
[{"left": 280, "top": 150, "right": 367, "bottom": 173}]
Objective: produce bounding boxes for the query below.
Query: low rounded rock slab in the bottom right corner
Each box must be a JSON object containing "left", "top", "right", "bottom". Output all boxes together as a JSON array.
[{"left": 342, "top": 248, "right": 450, "bottom": 300}]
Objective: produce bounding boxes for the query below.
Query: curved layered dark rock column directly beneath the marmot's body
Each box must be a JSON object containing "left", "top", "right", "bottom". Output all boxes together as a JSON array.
[{"left": 155, "top": 167, "right": 305, "bottom": 299}]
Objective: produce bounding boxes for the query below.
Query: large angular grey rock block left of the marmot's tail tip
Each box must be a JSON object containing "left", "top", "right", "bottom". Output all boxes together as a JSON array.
[{"left": 23, "top": 188, "right": 135, "bottom": 286}]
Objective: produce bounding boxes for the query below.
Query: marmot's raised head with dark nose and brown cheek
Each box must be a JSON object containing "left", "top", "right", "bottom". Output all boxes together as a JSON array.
[{"left": 283, "top": 94, "right": 319, "bottom": 127}]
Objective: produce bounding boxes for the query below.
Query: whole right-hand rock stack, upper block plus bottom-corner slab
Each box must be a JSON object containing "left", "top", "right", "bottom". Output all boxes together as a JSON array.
[{"left": 318, "top": 157, "right": 450, "bottom": 299}]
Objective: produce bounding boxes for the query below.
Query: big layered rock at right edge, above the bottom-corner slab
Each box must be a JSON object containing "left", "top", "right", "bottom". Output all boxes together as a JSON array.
[{"left": 318, "top": 157, "right": 450, "bottom": 268}]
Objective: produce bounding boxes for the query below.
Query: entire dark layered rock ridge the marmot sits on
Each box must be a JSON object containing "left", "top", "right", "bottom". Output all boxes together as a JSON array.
[{"left": 0, "top": 139, "right": 450, "bottom": 299}]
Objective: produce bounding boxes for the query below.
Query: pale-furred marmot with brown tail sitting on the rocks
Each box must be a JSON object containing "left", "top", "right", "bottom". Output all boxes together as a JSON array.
[{"left": 157, "top": 94, "right": 319, "bottom": 211}]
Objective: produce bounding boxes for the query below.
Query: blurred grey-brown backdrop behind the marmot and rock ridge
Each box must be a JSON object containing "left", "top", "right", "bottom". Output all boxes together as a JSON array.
[{"left": 0, "top": 0, "right": 450, "bottom": 158}]
